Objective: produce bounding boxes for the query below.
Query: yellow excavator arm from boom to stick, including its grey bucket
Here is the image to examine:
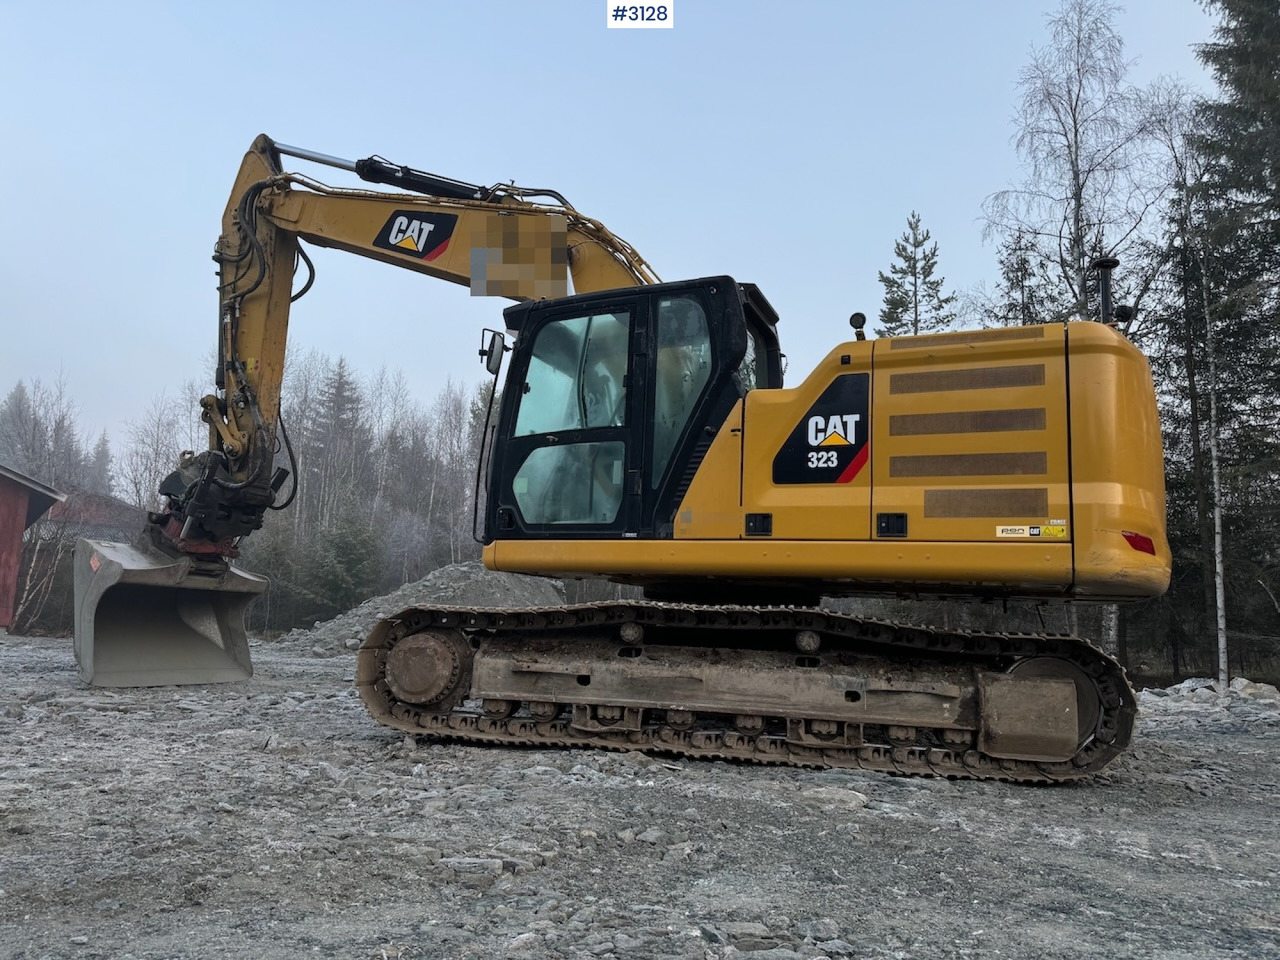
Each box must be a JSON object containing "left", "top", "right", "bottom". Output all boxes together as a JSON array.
[{"left": 76, "top": 136, "right": 657, "bottom": 686}]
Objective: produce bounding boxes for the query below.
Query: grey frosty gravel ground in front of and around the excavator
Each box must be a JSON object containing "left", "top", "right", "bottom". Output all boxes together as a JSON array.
[{"left": 0, "top": 578, "right": 1280, "bottom": 960}]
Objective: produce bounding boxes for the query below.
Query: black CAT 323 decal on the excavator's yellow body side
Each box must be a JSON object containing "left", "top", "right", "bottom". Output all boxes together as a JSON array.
[{"left": 773, "top": 374, "right": 870, "bottom": 484}]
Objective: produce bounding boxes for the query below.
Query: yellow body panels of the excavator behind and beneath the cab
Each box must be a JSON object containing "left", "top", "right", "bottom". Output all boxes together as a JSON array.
[{"left": 485, "top": 323, "right": 1170, "bottom": 609}]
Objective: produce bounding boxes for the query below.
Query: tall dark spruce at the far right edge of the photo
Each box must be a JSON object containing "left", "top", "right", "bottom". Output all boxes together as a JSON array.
[{"left": 1192, "top": 0, "right": 1280, "bottom": 678}]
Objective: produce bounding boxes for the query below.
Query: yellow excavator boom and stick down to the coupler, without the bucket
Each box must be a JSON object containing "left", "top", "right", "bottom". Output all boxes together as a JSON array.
[{"left": 163, "top": 136, "right": 657, "bottom": 557}]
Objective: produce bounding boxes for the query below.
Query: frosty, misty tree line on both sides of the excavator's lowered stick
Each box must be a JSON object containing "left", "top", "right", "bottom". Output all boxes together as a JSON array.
[{"left": 0, "top": 352, "right": 489, "bottom": 632}]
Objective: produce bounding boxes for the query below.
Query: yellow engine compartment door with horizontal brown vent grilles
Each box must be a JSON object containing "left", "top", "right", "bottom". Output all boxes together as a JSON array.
[{"left": 872, "top": 324, "right": 1071, "bottom": 543}]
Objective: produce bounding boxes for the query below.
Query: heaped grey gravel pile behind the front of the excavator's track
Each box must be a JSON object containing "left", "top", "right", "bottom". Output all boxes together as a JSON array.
[{"left": 275, "top": 561, "right": 564, "bottom": 657}]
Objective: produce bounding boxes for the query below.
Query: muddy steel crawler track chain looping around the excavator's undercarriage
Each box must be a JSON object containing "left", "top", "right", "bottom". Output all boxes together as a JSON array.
[{"left": 356, "top": 602, "right": 1137, "bottom": 783}]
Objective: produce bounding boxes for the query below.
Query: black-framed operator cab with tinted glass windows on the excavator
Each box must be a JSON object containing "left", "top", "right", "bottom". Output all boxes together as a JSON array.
[{"left": 485, "top": 276, "right": 782, "bottom": 541}]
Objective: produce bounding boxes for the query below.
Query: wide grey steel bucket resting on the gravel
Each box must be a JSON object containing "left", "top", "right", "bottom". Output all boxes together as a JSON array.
[{"left": 76, "top": 540, "right": 268, "bottom": 686}]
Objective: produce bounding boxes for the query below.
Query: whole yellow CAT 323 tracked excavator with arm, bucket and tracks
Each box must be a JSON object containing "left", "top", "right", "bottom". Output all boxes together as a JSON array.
[{"left": 76, "top": 137, "right": 1170, "bottom": 781}]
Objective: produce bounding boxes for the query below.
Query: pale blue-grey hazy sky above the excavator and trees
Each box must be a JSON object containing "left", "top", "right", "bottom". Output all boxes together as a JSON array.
[{"left": 0, "top": 0, "right": 1213, "bottom": 453}]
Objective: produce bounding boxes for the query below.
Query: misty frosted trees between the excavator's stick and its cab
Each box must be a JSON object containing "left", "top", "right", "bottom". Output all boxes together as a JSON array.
[{"left": 232, "top": 353, "right": 490, "bottom": 630}]
